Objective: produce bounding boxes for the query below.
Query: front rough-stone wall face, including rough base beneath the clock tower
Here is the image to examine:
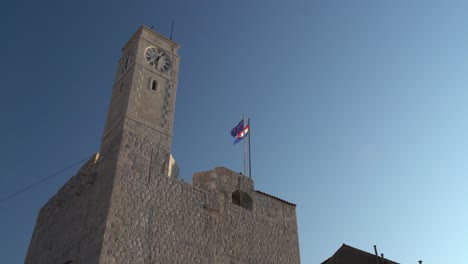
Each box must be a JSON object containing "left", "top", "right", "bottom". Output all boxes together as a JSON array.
[{"left": 100, "top": 121, "right": 300, "bottom": 264}]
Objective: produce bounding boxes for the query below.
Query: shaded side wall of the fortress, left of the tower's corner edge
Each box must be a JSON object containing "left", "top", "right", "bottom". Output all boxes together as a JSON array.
[{"left": 25, "top": 152, "right": 116, "bottom": 264}]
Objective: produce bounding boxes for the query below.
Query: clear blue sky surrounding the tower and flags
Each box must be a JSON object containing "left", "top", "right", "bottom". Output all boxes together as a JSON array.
[{"left": 0, "top": 0, "right": 468, "bottom": 264}]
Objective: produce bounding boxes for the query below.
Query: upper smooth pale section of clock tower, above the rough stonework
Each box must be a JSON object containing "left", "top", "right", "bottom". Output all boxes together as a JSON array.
[{"left": 101, "top": 26, "right": 179, "bottom": 154}]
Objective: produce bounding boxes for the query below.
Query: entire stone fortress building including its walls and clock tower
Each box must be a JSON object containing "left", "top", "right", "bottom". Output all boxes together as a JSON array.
[{"left": 25, "top": 26, "right": 300, "bottom": 264}]
